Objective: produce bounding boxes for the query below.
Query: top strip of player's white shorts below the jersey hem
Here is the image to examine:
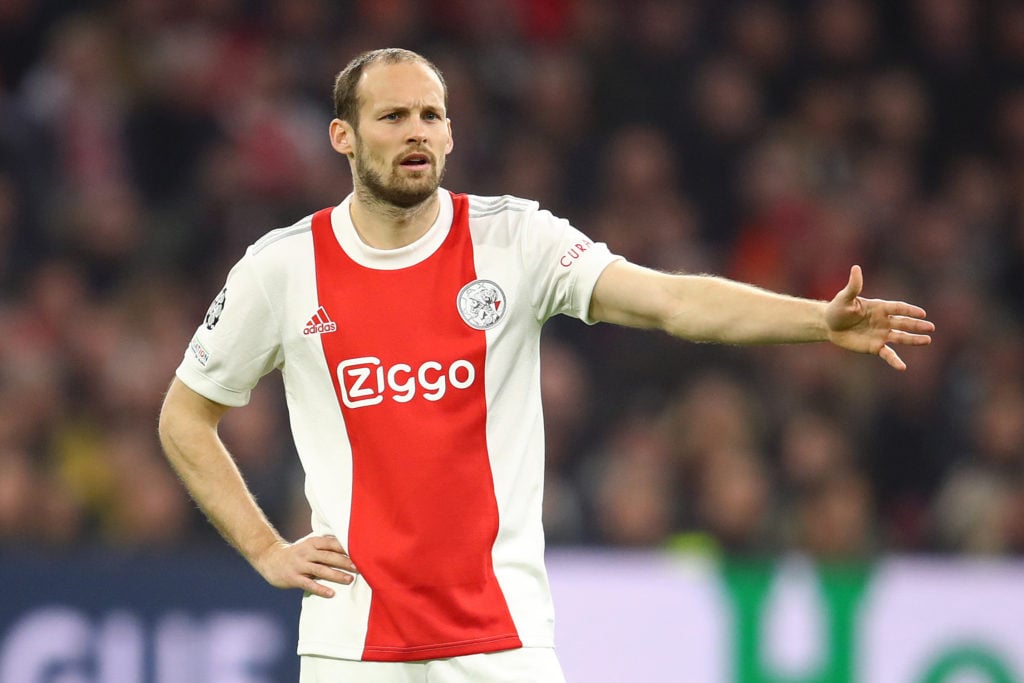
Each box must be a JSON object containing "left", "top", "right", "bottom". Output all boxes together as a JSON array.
[{"left": 299, "top": 647, "right": 565, "bottom": 683}]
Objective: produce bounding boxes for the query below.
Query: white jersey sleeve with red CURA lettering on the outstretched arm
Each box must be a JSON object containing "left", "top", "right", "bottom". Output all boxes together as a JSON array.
[{"left": 523, "top": 210, "right": 622, "bottom": 325}]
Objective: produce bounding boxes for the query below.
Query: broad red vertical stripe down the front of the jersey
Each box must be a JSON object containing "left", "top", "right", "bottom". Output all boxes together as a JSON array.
[{"left": 312, "top": 196, "right": 521, "bottom": 661}]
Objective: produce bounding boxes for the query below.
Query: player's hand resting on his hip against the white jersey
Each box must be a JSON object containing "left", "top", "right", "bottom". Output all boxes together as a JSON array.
[{"left": 253, "top": 536, "right": 356, "bottom": 598}]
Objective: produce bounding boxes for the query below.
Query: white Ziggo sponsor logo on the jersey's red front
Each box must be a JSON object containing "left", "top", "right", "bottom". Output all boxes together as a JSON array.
[{"left": 337, "top": 355, "right": 476, "bottom": 408}]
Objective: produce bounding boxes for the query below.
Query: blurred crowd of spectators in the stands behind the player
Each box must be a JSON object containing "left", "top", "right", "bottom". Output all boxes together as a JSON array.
[{"left": 0, "top": 0, "right": 1024, "bottom": 561}]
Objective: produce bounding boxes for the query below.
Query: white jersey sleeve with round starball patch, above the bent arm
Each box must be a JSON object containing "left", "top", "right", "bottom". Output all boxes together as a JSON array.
[{"left": 176, "top": 253, "right": 282, "bottom": 407}]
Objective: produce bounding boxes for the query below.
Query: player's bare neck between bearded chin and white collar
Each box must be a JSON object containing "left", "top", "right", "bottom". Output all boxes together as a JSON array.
[{"left": 348, "top": 187, "right": 440, "bottom": 249}]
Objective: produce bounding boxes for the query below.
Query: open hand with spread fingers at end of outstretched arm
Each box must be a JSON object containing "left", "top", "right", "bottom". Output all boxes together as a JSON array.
[{"left": 825, "top": 265, "right": 935, "bottom": 371}]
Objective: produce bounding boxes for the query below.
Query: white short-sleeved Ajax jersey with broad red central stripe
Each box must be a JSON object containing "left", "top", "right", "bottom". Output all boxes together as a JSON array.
[{"left": 177, "top": 189, "right": 616, "bottom": 660}]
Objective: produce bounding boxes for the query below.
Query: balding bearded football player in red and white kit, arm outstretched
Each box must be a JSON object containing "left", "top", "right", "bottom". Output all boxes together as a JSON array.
[{"left": 160, "top": 49, "right": 933, "bottom": 683}]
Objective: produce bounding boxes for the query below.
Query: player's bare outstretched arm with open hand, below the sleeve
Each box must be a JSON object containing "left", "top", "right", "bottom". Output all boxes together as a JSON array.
[{"left": 590, "top": 261, "right": 935, "bottom": 370}]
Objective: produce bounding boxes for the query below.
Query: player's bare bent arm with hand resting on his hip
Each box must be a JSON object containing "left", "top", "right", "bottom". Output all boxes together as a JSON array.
[{"left": 160, "top": 379, "right": 355, "bottom": 598}]
